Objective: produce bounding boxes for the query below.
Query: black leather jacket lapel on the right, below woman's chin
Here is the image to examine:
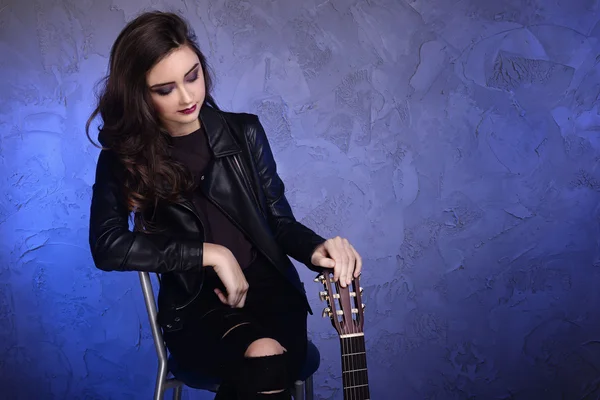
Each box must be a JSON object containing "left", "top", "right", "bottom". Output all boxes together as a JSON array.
[{"left": 200, "top": 104, "right": 242, "bottom": 157}]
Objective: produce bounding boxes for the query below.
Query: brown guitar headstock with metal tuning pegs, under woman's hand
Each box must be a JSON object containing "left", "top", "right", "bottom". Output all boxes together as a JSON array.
[{"left": 315, "top": 271, "right": 365, "bottom": 336}]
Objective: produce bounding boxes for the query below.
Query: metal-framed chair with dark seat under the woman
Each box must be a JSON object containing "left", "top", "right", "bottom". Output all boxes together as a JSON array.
[{"left": 138, "top": 271, "right": 320, "bottom": 400}]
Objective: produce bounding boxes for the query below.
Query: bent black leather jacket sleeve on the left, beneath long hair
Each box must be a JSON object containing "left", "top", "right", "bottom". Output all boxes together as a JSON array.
[{"left": 89, "top": 150, "right": 203, "bottom": 273}]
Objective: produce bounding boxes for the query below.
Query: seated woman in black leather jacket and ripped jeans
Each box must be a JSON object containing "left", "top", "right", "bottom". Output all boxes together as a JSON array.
[{"left": 86, "top": 12, "right": 362, "bottom": 399}]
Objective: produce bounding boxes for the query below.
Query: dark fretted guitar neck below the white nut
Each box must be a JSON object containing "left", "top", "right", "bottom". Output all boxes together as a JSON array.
[{"left": 340, "top": 333, "right": 370, "bottom": 400}]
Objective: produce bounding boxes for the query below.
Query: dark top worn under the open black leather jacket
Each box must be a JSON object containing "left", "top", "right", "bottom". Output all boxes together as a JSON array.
[{"left": 171, "top": 127, "right": 256, "bottom": 268}]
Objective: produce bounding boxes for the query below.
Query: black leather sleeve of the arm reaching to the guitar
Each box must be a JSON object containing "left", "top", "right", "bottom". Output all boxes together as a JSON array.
[{"left": 246, "top": 115, "right": 325, "bottom": 271}]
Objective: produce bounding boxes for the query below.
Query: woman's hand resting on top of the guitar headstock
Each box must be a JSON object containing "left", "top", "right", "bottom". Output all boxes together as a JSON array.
[{"left": 310, "top": 236, "right": 362, "bottom": 287}]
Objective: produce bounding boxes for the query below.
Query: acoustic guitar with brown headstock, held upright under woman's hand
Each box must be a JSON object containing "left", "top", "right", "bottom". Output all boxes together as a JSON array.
[{"left": 315, "top": 272, "right": 370, "bottom": 400}]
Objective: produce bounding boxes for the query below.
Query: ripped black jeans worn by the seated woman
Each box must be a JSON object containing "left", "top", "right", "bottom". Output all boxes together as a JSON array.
[{"left": 164, "top": 255, "right": 307, "bottom": 396}]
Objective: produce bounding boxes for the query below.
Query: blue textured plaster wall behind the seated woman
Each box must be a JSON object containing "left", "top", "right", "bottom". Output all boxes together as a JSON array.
[{"left": 0, "top": 0, "right": 600, "bottom": 400}]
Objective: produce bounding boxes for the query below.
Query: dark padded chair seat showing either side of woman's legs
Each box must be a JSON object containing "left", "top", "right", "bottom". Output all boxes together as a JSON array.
[{"left": 167, "top": 340, "right": 321, "bottom": 393}]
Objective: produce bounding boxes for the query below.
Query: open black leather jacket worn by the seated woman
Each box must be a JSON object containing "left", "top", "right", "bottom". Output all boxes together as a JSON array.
[{"left": 89, "top": 106, "right": 325, "bottom": 326}]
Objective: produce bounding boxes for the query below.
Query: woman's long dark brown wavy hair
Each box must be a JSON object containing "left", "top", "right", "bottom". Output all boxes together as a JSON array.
[{"left": 85, "top": 11, "right": 219, "bottom": 227}]
